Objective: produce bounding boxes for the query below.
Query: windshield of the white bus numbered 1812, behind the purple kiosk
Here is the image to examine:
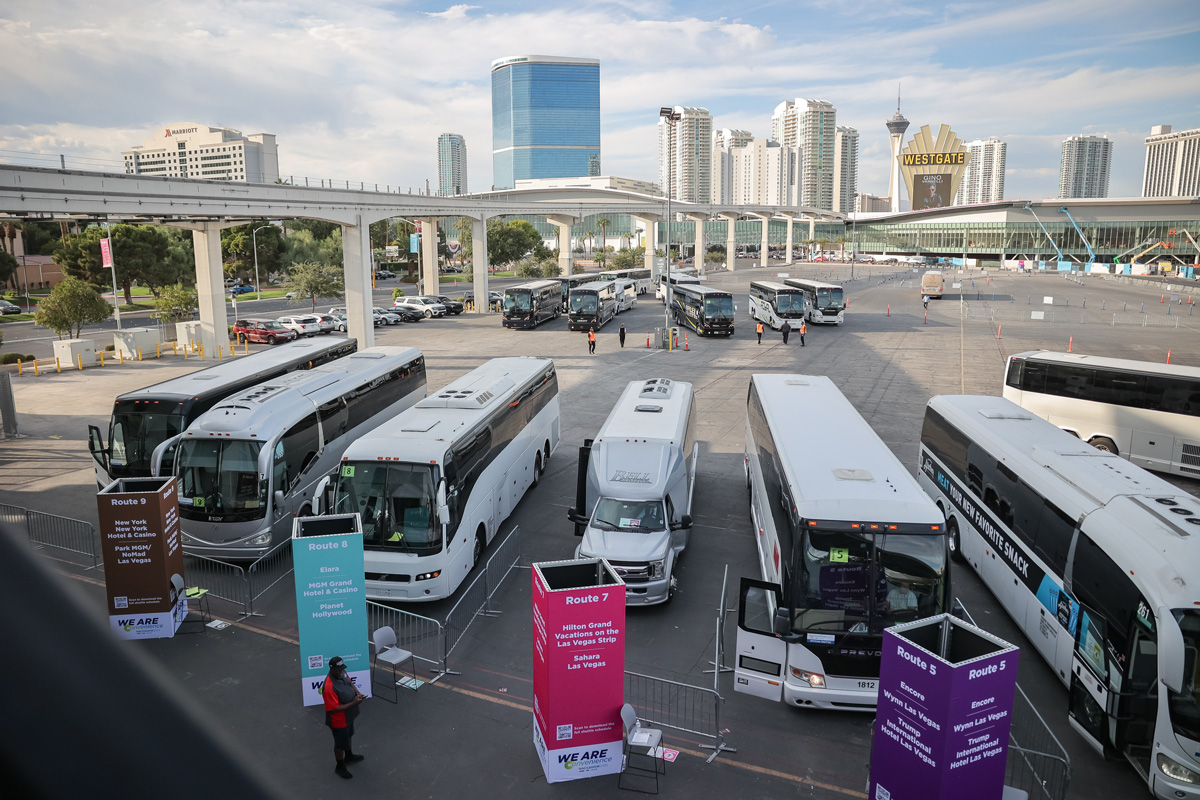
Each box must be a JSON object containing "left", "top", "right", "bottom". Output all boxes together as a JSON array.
[{"left": 792, "top": 529, "right": 946, "bottom": 633}]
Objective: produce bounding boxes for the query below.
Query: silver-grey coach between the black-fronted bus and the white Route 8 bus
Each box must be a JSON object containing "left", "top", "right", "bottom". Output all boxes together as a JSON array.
[{"left": 152, "top": 347, "right": 425, "bottom": 559}]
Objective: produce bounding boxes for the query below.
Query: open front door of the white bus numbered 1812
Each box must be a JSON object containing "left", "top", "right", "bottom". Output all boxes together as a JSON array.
[{"left": 733, "top": 578, "right": 787, "bottom": 702}]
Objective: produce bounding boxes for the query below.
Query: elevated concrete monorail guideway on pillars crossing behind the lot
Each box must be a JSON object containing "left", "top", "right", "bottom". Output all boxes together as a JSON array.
[{"left": 0, "top": 164, "right": 844, "bottom": 353}]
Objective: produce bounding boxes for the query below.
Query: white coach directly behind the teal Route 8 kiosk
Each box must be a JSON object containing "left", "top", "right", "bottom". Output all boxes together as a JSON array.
[{"left": 332, "top": 357, "right": 559, "bottom": 601}]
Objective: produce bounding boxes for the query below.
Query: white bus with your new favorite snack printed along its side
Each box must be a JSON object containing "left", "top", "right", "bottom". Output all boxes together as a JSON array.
[{"left": 920, "top": 396, "right": 1200, "bottom": 798}]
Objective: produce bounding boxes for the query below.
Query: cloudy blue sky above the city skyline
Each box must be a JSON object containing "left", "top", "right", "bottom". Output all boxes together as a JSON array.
[{"left": 0, "top": 0, "right": 1200, "bottom": 199}]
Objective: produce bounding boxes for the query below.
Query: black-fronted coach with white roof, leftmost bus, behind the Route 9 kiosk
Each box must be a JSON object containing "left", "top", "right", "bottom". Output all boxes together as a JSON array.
[{"left": 88, "top": 338, "right": 359, "bottom": 488}]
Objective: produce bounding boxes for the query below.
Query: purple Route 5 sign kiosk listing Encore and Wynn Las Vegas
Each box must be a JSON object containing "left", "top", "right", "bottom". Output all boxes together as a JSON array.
[{"left": 868, "top": 614, "right": 1019, "bottom": 800}]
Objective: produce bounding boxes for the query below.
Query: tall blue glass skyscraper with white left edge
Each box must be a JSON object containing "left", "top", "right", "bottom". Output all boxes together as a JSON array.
[{"left": 492, "top": 55, "right": 600, "bottom": 190}]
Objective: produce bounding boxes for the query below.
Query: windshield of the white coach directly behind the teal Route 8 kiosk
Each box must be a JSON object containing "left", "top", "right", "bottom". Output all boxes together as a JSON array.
[{"left": 334, "top": 462, "right": 442, "bottom": 555}]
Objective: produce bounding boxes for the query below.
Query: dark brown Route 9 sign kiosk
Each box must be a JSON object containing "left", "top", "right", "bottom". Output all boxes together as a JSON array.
[{"left": 96, "top": 477, "right": 187, "bottom": 639}]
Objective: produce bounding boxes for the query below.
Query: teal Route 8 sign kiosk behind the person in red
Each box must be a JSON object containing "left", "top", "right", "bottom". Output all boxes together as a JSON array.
[{"left": 292, "top": 513, "right": 371, "bottom": 705}]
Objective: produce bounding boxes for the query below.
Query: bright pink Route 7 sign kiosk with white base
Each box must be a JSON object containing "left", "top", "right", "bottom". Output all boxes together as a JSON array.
[{"left": 533, "top": 559, "right": 625, "bottom": 783}]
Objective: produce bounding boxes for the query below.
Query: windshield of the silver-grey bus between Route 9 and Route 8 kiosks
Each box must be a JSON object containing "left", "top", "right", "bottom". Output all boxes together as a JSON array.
[{"left": 175, "top": 439, "right": 268, "bottom": 522}]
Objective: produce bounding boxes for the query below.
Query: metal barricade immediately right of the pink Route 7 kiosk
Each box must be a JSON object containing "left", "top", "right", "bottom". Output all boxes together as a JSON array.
[{"left": 625, "top": 672, "right": 737, "bottom": 764}]
